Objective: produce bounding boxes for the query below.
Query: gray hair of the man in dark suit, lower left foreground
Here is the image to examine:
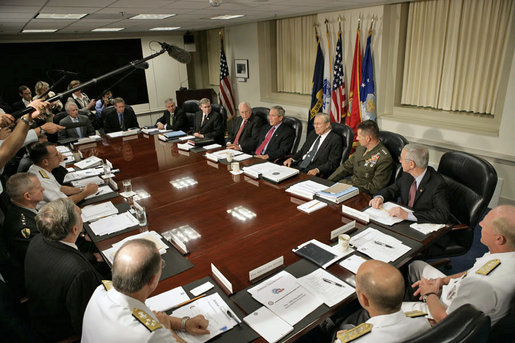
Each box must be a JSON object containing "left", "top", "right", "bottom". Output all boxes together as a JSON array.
[{"left": 36, "top": 198, "right": 82, "bottom": 241}]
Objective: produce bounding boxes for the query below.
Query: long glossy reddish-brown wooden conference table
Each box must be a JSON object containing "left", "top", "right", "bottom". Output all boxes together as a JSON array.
[{"left": 76, "top": 133, "right": 450, "bottom": 341}]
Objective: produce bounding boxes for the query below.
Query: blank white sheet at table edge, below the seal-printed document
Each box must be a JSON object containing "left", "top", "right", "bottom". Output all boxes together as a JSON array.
[{"left": 243, "top": 306, "right": 293, "bottom": 343}]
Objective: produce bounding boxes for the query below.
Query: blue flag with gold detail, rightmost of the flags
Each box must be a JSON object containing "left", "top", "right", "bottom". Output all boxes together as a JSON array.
[{"left": 359, "top": 29, "right": 377, "bottom": 120}]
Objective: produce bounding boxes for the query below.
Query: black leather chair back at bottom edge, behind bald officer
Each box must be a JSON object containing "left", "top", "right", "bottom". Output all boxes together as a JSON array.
[{"left": 405, "top": 304, "right": 490, "bottom": 343}]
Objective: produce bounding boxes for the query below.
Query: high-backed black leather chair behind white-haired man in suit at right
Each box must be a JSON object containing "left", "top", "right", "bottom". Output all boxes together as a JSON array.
[{"left": 428, "top": 151, "right": 497, "bottom": 258}]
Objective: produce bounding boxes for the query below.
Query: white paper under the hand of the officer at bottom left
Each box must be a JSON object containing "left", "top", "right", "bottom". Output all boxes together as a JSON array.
[{"left": 172, "top": 293, "right": 238, "bottom": 343}]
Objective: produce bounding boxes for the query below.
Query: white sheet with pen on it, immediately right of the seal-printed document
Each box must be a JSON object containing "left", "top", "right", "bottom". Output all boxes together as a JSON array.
[{"left": 297, "top": 268, "right": 354, "bottom": 307}]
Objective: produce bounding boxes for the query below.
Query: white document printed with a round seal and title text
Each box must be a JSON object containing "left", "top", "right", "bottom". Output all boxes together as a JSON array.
[{"left": 248, "top": 271, "right": 323, "bottom": 325}]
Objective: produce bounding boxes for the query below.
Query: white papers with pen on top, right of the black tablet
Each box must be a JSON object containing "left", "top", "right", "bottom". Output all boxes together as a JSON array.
[{"left": 350, "top": 227, "right": 411, "bottom": 262}]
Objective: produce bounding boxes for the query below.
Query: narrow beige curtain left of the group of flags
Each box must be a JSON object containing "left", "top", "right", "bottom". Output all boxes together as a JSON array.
[{"left": 276, "top": 15, "right": 316, "bottom": 94}]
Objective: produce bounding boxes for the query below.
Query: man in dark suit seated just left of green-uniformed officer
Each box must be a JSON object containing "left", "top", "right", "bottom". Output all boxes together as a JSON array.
[{"left": 284, "top": 113, "right": 343, "bottom": 177}]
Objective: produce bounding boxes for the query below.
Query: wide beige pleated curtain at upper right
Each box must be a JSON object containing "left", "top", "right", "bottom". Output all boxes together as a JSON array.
[{"left": 401, "top": 0, "right": 513, "bottom": 114}]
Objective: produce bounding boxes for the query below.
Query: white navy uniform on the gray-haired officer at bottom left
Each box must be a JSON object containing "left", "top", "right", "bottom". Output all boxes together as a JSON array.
[{"left": 81, "top": 285, "right": 177, "bottom": 343}]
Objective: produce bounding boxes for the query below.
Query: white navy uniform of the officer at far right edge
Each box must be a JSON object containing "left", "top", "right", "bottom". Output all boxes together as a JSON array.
[{"left": 402, "top": 251, "right": 515, "bottom": 326}]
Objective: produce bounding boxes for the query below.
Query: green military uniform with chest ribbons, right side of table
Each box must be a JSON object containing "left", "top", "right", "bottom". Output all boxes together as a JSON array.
[{"left": 328, "top": 142, "right": 393, "bottom": 195}]
